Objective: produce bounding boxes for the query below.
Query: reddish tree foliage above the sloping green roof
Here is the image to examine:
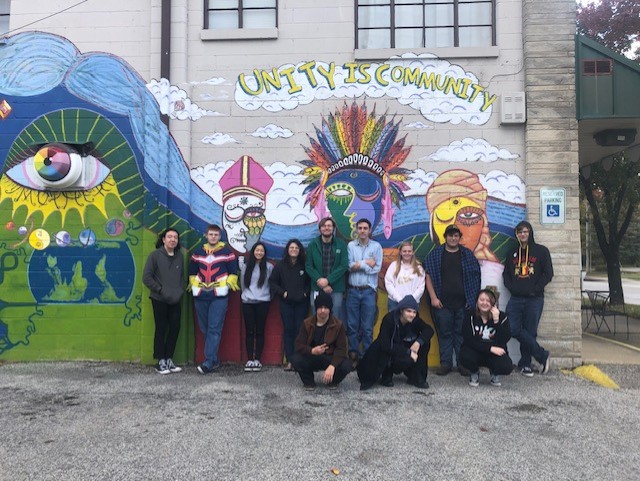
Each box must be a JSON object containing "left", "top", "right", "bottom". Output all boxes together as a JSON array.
[{"left": 576, "top": 0, "right": 640, "bottom": 62}]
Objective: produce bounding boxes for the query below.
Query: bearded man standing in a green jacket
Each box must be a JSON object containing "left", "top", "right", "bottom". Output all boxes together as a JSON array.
[{"left": 305, "top": 217, "right": 349, "bottom": 320}]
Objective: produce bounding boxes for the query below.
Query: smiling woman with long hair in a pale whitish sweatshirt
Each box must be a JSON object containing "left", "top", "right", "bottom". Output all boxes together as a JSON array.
[{"left": 384, "top": 241, "right": 425, "bottom": 311}]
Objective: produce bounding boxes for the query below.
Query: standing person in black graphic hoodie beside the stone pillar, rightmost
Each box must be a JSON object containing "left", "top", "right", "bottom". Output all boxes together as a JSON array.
[{"left": 502, "top": 221, "right": 553, "bottom": 377}]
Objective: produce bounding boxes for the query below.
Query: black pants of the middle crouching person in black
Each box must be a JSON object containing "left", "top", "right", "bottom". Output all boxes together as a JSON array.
[{"left": 358, "top": 340, "right": 431, "bottom": 384}]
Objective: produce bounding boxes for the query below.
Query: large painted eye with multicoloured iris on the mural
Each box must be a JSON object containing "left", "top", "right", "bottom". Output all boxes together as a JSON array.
[{"left": 6, "top": 143, "right": 110, "bottom": 191}]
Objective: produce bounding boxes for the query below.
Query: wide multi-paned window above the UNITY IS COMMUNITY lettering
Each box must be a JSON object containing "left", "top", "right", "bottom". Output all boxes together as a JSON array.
[{"left": 356, "top": 0, "right": 496, "bottom": 49}]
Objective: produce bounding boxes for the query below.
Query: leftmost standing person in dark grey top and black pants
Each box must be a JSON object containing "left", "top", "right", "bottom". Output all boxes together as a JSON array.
[{"left": 142, "top": 229, "right": 184, "bottom": 374}]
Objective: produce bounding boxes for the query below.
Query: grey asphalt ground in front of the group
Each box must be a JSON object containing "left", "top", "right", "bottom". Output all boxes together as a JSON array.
[{"left": 0, "top": 362, "right": 640, "bottom": 481}]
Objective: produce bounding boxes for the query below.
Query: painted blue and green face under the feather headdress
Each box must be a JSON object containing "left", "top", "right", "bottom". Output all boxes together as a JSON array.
[{"left": 325, "top": 169, "right": 382, "bottom": 239}]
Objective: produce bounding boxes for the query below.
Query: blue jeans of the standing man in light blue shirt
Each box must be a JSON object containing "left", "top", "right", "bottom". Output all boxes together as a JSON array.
[{"left": 347, "top": 287, "right": 376, "bottom": 355}]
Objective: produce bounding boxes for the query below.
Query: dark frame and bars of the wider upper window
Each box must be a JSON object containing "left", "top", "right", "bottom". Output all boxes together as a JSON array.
[{"left": 354, "top": 0, "right": 497, "bottom": 51}]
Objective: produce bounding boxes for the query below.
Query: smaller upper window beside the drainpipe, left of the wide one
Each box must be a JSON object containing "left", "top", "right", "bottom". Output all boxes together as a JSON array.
[{"left": 204, "top": 0, "right": 278, "bottom": 30}]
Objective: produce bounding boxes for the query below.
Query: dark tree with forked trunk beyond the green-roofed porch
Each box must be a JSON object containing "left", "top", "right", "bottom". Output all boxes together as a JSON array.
[{"left": 580, "top": 146, "right": 640, "bottom": 304}]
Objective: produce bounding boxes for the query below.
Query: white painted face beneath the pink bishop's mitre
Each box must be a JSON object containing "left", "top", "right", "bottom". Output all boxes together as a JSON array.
[{"left": 222, "top": 194, "right": 267, "bottom": 254}]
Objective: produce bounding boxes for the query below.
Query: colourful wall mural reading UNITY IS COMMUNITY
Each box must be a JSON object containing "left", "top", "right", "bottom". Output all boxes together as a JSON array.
[{"left": 0, "top": 32, "right": 525, "bottom": 359}]
